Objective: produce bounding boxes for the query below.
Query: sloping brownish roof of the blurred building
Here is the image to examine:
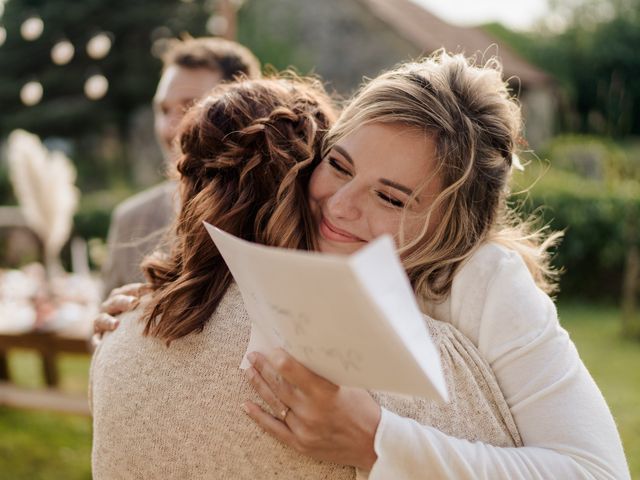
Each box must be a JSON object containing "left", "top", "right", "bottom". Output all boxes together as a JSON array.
[{"left": 360, "top": 0, "right": 551, "bottom": 88}]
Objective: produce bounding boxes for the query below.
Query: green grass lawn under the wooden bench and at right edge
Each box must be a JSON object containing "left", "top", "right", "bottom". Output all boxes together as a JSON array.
[{"left": 0, "top": 303, "right": 640, "bottom": 480}]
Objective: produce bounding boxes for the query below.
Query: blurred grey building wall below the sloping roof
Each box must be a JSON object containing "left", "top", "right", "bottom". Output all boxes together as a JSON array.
[{"left": 238, "top": 0, "right": 421, "bottom": 94}]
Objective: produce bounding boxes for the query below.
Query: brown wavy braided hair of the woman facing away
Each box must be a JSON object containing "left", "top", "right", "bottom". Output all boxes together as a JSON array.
[{"left": 142, "top": 77, "right": 335, "bottom": 344}]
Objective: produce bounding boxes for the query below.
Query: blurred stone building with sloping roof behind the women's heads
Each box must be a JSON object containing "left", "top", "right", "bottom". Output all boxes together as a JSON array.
[{"left": 238, "top": 0, "right": 556, "bottom": 148}]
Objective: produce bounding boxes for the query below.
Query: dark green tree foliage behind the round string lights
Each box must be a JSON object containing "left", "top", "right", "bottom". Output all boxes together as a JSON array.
[{"left": 0, "top": 0, "right": 207, "bottom": 138}]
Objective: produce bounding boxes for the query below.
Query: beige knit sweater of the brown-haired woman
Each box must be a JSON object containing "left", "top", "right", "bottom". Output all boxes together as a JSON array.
[{"left": 90, "top": 284, "right": 521, "bottom": 480}]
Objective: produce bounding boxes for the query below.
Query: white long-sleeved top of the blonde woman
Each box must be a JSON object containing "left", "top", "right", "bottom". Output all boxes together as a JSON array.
[{"left": 369, "top": 244, "right": 630, "bottom": 480}]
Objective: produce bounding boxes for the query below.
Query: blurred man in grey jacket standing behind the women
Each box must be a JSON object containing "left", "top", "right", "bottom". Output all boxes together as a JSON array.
[{"left": 102, "top": 37, "right": 260, "bottom": 295}]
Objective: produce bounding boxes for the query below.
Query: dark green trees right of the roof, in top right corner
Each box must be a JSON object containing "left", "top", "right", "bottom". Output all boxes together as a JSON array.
[{"left": 486, "top": 0, "right": 640, "bottom": 138}]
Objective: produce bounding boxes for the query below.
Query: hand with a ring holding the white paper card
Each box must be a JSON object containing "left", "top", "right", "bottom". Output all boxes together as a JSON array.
[{"left": 242, "top": 349, "right": 380, "bottom": 471}]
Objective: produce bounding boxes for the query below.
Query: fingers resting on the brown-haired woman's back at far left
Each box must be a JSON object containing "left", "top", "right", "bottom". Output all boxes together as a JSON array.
[{"left": 91, "top": 283, "right": 151, "bottom": 349}]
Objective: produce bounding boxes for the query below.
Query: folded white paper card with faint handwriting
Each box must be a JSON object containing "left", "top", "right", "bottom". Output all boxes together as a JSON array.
[{"left": 205, "top": 223, "right": 448, "bottom": 401}]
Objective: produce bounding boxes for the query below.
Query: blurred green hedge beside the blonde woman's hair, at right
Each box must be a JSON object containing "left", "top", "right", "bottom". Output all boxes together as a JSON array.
[{"left": 514, "top": 141, "right": 640, "bottom": 301}]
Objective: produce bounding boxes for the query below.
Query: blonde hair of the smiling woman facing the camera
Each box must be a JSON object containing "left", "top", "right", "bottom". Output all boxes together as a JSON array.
[{"left": 323, "top": 50, "right": 559, "bottom": 301}]
